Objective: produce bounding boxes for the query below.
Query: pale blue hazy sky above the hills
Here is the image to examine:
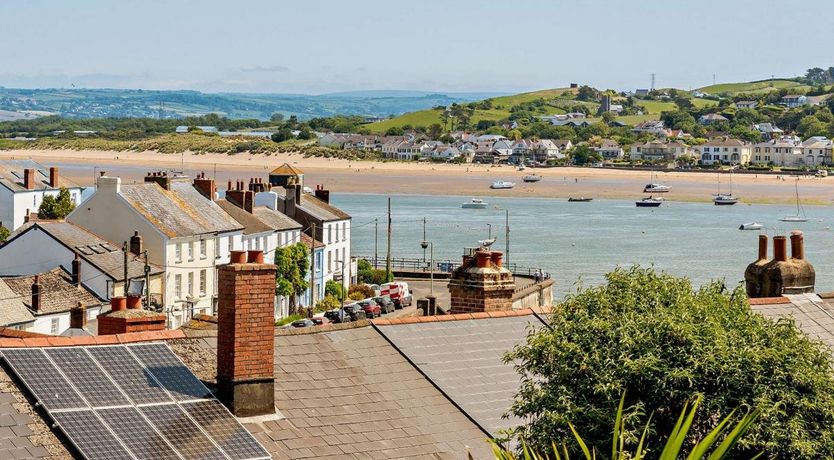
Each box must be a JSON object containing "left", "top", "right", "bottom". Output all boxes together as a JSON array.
[{"left": 0, "top": 0, "right": 834, "bottom": 94}]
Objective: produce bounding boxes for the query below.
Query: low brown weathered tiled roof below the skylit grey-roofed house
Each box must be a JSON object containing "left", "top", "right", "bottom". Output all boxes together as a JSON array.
[{"left": 2, "top": 268, "right": 103, "bottom": 316}]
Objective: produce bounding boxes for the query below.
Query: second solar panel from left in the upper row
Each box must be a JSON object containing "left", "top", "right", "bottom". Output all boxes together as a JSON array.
[{"left": 44, "top": 347, "right": 130, "bottom": 407}]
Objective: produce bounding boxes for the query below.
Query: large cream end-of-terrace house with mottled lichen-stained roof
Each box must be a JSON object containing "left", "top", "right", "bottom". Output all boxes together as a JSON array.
[{"left": 67, "top": 173, "right": 243, "bottom": 327}]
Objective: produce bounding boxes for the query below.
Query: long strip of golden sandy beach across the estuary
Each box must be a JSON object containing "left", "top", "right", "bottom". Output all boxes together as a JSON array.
[{"left": 0, "top": 150, "right": 834, "bottom": 205}]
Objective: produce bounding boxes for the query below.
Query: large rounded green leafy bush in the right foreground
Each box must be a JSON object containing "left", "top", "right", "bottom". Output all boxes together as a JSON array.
[{"left": 507, "top": 267, "right": 834, "bottom": 459}]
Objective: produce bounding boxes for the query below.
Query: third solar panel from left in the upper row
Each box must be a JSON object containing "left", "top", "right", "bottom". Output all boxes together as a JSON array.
[{"left": 87, "top": 346, "right": 173, "bottom": 404}]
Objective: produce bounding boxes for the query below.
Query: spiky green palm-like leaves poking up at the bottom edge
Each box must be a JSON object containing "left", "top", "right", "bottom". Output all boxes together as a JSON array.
[{"left": 492, "top": 394, "right": 761, "bottom": 460}]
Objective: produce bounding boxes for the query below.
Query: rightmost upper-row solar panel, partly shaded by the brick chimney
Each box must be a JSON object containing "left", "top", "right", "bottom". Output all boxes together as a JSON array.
[{"left": 129, "top": 343, "right": 211, "bottom": 401}]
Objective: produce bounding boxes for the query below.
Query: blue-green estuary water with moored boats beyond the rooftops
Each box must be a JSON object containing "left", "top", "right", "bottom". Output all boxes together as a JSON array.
[{"left": 332, "top": 193, "right": 834, "bottom": 298}]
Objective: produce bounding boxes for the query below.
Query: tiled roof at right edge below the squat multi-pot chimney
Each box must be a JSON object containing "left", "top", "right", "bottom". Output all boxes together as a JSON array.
[{"left": 750, "top": 294, "right": 834, "bottom": 351}]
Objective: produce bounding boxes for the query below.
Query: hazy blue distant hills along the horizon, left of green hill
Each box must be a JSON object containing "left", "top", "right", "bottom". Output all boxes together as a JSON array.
[{"left": 0, "top": 87, "right": 495, "bottom": 121}]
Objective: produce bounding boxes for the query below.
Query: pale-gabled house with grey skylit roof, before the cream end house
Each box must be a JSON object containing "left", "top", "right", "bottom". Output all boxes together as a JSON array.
[{"left": 0, "top": 221, "right": 165, "bottom": 306}]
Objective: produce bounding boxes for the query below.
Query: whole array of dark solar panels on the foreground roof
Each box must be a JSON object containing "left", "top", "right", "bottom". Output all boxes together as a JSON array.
[{"left": 0, "top": 343, "right": 270, "bottom": 460}]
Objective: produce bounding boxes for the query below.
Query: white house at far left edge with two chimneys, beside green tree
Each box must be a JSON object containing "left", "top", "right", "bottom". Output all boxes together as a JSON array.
[{"left": 0, "top": 160, "right": 85, "bottom": 231}]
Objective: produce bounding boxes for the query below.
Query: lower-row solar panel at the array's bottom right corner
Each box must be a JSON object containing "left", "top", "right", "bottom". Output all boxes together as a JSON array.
[{"left": 182, "top": 400, "right": 270, "bottom": 460}]
